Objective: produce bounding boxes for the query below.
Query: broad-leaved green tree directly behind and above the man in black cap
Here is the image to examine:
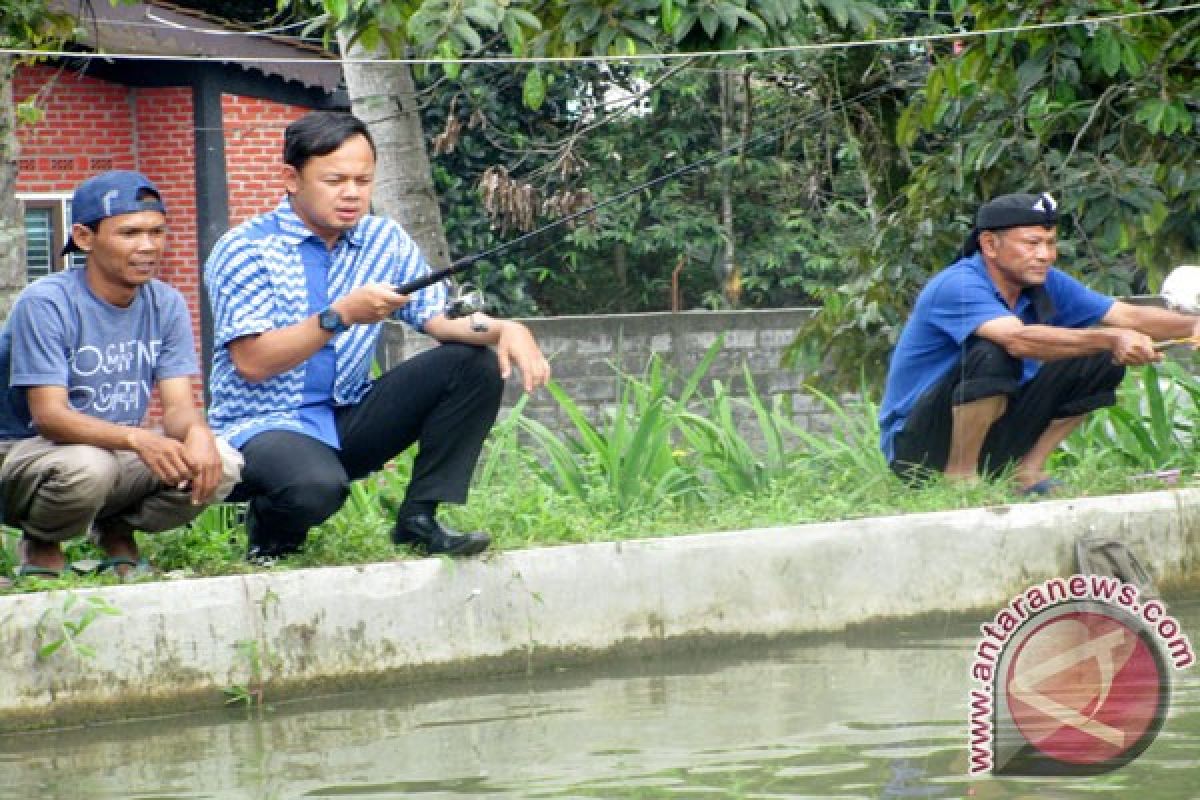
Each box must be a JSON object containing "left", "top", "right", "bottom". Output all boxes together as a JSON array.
[{"left": 796, "top": 0, "right": 1200, "bottom": 388}]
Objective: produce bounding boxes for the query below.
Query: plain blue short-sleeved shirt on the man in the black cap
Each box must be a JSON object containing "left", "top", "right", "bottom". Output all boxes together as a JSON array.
[{"left": 880, "top": 253, "right": 1114, "bottom": 462}]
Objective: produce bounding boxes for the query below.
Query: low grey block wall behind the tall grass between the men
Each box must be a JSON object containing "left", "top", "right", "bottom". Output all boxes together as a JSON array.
[{"left": 380, "top": 308, "right": 826, "bottom": 431}]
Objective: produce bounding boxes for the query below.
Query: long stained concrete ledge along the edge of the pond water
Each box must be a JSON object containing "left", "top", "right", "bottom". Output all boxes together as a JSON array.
[{"left": 0, "top": 489, "right": 1200, "bottom": 729}]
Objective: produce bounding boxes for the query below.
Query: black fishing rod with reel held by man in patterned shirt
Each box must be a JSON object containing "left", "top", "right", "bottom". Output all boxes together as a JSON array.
[{"left": 394, "top": 82, "right": 905, "bottom": 311}]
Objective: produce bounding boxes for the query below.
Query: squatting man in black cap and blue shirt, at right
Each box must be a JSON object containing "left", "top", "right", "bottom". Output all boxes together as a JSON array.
[{"left": 880, "top": 193, "right": 1200, "bottom": 494}]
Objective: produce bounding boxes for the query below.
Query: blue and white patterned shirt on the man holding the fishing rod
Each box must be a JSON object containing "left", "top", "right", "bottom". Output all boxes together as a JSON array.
[{"left": 204, "top": 198, "right": 446, "bottom": 447}]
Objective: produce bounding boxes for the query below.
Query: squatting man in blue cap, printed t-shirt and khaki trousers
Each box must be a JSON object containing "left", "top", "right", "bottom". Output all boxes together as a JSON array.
[{"left": 0, "top": 172, "right": 241, "bottom": 576}]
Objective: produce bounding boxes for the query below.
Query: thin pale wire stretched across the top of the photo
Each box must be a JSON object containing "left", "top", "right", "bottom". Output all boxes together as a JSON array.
[{"left": 0, "top": 2, "right": 1200, "bottom": 66}]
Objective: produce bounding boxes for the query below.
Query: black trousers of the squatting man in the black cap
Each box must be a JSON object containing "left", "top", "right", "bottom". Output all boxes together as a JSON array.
[{"left": 892, "top": 336, "right": 1124, "bottom": 481}]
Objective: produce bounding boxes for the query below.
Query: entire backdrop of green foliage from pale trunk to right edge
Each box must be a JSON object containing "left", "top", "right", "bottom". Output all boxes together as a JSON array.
[{"left": 405, "top": 0, "right": 1200, "bottom": 385}]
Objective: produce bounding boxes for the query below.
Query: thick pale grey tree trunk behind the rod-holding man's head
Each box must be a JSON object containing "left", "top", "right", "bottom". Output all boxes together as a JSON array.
[{"left": 338, "top": 34, "right": 450, "bottom": 267}]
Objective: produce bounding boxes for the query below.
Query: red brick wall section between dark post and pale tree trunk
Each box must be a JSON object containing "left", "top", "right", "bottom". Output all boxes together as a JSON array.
[{"left": 221, "top": 95, "right": 308, "bottom": 224}]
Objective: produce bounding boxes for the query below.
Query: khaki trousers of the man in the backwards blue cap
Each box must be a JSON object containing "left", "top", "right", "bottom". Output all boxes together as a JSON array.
[{"left": 0, "top": 437, "right": 242, "bottom": 542}]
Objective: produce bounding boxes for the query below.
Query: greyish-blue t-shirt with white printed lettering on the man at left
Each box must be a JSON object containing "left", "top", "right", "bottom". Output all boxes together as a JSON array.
[{"left": 0, "top": 269, "right": 199, "bottom": 439}]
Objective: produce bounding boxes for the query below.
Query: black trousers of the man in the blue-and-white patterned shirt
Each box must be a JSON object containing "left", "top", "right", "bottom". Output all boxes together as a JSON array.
[{"left": 229, "top": 344, "right": 504, "bottom": 555}]
